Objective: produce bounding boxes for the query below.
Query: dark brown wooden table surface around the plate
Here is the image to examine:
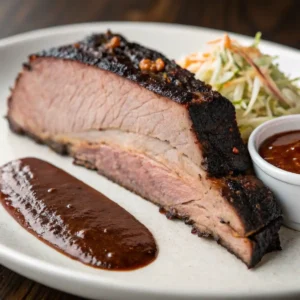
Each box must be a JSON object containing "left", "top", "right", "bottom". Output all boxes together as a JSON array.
[{"left": 0, "top": 0, "right": 300, "bottom": 300}]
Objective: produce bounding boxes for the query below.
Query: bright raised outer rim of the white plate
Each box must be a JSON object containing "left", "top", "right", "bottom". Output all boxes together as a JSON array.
[{"left": 0, "top": 21, "right": 300, "bottom": 299}]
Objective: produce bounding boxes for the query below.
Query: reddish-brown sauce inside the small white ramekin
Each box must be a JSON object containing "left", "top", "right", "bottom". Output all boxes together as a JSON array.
[{"left": 259, "top": 130, "right": 300, "bottom": 174}]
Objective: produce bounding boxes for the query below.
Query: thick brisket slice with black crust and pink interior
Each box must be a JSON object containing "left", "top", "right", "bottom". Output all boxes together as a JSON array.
[{"left": 8, "top": 32, "right": 282, "bottom": 267}]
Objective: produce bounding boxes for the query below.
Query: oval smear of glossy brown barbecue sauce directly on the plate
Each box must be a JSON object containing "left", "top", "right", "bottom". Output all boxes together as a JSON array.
[{"left": 0, "top": 158, "right": 157, "bottom": 270}]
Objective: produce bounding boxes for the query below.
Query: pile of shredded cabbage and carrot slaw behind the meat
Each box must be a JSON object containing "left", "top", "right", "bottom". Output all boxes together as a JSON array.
[{"left": 178, "top": 32, "right": 300, "bottom": 141}]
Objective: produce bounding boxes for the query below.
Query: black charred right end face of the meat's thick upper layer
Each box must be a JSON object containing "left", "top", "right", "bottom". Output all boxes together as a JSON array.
[{"left": 188, "top": 96, "right": 251, "bottom": 177}]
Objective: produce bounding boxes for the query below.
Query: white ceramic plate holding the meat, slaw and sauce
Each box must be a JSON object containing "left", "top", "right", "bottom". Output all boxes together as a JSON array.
[{"left": 0, "top": 23, "right": 300, "bottom": 299}]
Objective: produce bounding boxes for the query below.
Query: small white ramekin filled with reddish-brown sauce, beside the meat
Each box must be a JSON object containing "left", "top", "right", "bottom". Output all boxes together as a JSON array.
[{"left": 248, "top": 115, "right": 300, "bottom": 231}]
